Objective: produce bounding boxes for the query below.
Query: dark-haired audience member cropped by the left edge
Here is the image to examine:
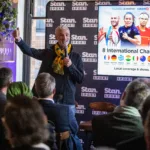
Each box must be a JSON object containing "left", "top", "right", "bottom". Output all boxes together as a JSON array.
[{"left": 0, "top": 67, "right": 12, "bottom": 116}]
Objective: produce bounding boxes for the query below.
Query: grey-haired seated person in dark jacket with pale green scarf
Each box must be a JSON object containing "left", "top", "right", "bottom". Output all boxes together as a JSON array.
[{"left": 92, "top": 80, "right": 150, "bottom": 147}]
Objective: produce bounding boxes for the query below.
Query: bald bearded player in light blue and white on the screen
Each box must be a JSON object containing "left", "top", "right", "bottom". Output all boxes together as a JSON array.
[{"left": 98, "top": 14, "right": 120, "bottom": 47}]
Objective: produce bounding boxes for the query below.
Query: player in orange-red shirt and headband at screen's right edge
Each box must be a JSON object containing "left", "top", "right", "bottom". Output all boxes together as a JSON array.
[{"left": 137, "top": 12, "right": 150, "bottom": 47}]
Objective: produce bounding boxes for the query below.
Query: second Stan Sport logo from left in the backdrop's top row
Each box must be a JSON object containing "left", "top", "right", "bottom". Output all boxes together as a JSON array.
[{"left": 72, "top": 2, "right": 88, "bottom": 11}]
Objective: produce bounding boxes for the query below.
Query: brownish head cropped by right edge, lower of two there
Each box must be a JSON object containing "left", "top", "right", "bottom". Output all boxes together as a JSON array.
[{"left": 144, "top": 110, "right": 150, "bottom": 150}]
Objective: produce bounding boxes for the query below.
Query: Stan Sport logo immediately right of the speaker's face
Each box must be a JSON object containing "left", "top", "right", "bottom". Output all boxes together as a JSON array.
[{"left": 71, "top": 34, "right": 87, "bottom": 45}]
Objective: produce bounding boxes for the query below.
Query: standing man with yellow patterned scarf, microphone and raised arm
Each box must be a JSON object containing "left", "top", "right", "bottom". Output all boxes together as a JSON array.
[{"left": 12, "top": 25, "right": 84, "bottom": 108}]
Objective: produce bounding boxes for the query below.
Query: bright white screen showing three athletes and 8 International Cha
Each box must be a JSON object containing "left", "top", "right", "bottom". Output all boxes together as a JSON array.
[{"left": 98, "top": 6, "right": 150, "bottom": 76}]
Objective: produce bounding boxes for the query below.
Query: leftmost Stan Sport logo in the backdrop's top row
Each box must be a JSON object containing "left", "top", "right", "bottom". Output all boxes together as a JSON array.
[{"left": 50, "top": 2, "right": 66, "bottom": 11}]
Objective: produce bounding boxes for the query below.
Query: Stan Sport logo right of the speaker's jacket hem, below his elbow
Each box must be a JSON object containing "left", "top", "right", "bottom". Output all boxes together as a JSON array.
[{"left": 81, "top": 86, "right": 98, "bottom": 97}]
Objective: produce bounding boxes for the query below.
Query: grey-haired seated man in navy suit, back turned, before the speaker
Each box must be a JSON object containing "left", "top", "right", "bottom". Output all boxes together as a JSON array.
[{"left": 35, "top": 73, "right": 82, "bottom": 150}]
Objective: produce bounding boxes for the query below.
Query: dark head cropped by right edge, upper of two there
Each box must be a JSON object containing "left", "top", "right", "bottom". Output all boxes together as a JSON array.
[{"left": 141, "top": 95, "right": 150, "bottom": 124}]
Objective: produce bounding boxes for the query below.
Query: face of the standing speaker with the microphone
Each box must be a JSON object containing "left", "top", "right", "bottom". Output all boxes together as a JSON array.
[{"left": 56, "top": 29, "right": 70, "bottom": 48}]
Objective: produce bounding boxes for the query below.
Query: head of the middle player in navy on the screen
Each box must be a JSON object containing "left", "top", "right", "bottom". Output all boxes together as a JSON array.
[{"left": 124, "top": 12, "right": 135, "bottom": 27}]
